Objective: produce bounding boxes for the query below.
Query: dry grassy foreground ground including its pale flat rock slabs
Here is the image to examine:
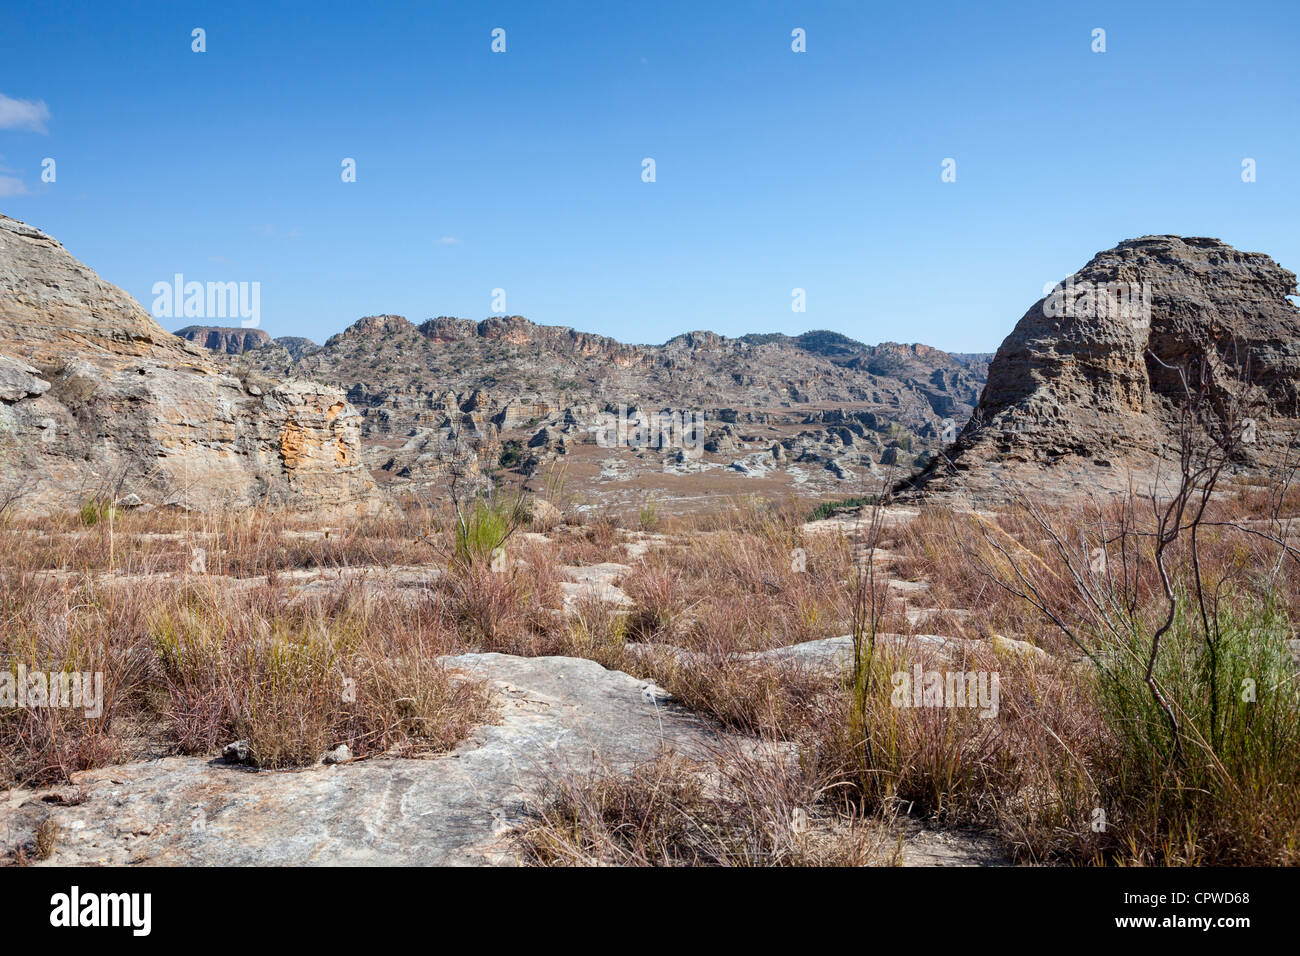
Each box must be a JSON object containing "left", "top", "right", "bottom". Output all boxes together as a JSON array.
[{"left": 0, "top": 486, "right": 1300, "bottom": 866}]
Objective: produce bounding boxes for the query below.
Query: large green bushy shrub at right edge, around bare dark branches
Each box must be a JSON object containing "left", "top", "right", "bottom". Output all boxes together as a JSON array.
[{"left": 1097, "top": 594, "right": 1300, "bottom": 864}]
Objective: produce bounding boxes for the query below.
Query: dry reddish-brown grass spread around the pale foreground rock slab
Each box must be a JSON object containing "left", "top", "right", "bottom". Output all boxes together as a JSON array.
[{"left": 0, "top": 484, "right": 1300, "bottom": 865}]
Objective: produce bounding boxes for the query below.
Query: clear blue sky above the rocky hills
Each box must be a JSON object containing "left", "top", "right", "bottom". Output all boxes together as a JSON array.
[{"left": 0, "top": 0, "right": 1300, "bottom": 351}]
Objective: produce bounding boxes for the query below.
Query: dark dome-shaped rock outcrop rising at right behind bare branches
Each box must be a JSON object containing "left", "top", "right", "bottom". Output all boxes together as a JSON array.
[{"left": 913, "top": 235, "right": 1300, "bottom": 496}]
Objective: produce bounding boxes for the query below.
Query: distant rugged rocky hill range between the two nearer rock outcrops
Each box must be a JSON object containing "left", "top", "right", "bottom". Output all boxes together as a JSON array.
[{"left": 226, "top": 315, "right": 985, "bottom": 502}]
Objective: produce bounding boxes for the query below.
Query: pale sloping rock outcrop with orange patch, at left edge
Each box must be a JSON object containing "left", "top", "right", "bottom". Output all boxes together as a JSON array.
[{"left": 0, "top": 216, "right": 374, "bottom": 511}]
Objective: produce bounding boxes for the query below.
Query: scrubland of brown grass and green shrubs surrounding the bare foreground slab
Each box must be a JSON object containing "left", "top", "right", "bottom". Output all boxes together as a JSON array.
[{"left": 0, "top": 481, "right": 1300, "bottom": 865}]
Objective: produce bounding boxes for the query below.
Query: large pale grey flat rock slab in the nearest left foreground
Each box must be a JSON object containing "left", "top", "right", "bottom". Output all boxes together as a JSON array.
[{"left": 0, "top": 654, "right": 718, "bottom": 866}]
